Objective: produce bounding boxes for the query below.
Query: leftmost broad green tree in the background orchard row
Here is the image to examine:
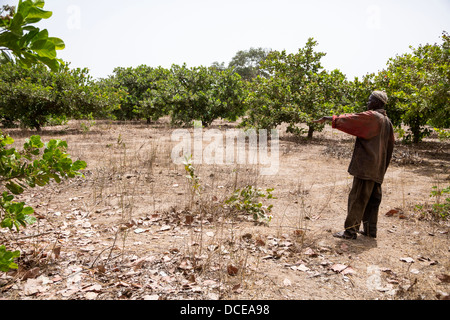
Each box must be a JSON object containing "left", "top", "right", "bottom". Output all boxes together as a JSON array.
[{"left": 0, "top": 62, "right": 119, "bottom": 130}]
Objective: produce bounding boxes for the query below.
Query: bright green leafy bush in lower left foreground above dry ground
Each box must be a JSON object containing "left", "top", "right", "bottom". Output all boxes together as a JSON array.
[{"left": 0, "top": 132, "right": 86, "bottom": 271}]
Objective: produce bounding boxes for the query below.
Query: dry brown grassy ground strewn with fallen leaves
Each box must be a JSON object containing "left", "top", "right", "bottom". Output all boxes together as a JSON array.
[{"left": 2, "top": 119, "right": 450, "bottom": 299}]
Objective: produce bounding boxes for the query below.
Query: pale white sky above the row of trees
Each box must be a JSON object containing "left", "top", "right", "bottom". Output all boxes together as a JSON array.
[{"left": 27, "top": 0, "right": 450, "bottom": 80}]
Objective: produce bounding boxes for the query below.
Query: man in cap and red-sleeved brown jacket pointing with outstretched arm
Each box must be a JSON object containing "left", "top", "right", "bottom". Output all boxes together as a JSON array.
[{"left": 314, "top": 91, "right": 394, "bottom": 239}]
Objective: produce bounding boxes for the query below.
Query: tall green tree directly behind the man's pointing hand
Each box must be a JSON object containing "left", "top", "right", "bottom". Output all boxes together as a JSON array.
[{"left": 244, "top": 38, "right": 346, "bottom": 138}]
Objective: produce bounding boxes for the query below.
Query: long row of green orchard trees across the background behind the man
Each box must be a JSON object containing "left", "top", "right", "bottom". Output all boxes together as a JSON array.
[{"left": 0, "top": 2, "right": 450, "bottom": 142}]
